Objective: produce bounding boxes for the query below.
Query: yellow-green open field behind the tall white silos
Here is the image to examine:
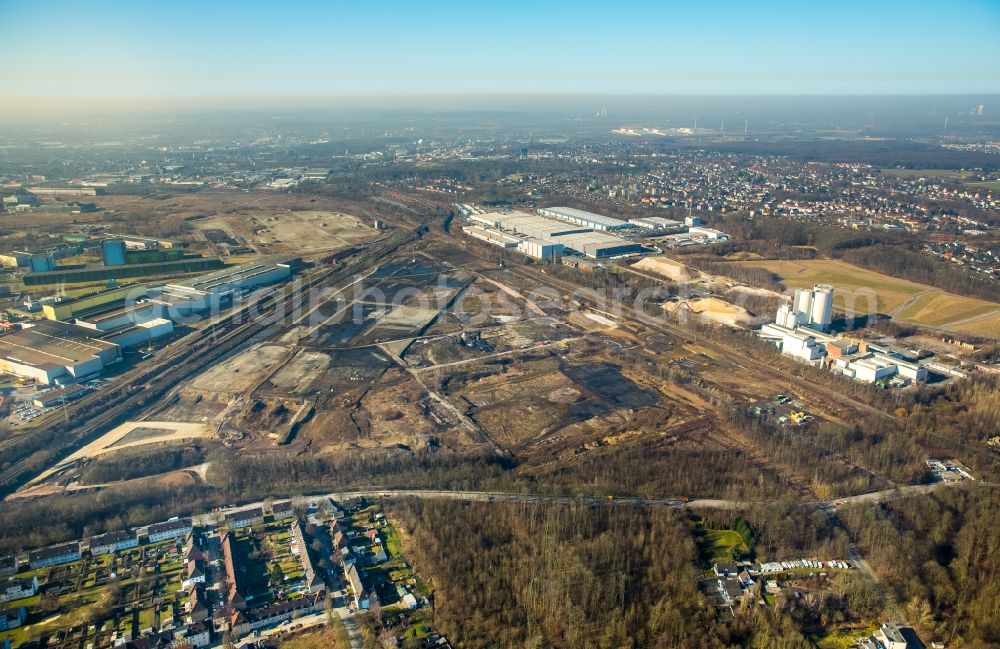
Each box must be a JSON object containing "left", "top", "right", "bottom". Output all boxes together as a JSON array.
[{"left": 741, "top": 259, "right": 1000, "bottom": 333}]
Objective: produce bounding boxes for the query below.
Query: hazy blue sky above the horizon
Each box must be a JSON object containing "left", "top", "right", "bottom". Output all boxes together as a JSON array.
[{"left": 0, "top": 0, "right": 1000, "bottom": 104}]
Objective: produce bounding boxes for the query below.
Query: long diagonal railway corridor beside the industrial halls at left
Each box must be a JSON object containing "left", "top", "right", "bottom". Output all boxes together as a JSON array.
[{"left": 0, "top": 226, "right": 426, "bottom": 495}]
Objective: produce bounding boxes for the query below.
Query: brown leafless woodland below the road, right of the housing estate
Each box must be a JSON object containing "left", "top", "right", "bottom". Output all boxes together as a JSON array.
[{"left": 390, "top": 500, "right": 809, "bottom": 649}]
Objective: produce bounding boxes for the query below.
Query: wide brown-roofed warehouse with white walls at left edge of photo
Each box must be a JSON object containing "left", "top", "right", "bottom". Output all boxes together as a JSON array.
[{"left": 0, "top": 320, "right": 121, "bottom": 385}]
